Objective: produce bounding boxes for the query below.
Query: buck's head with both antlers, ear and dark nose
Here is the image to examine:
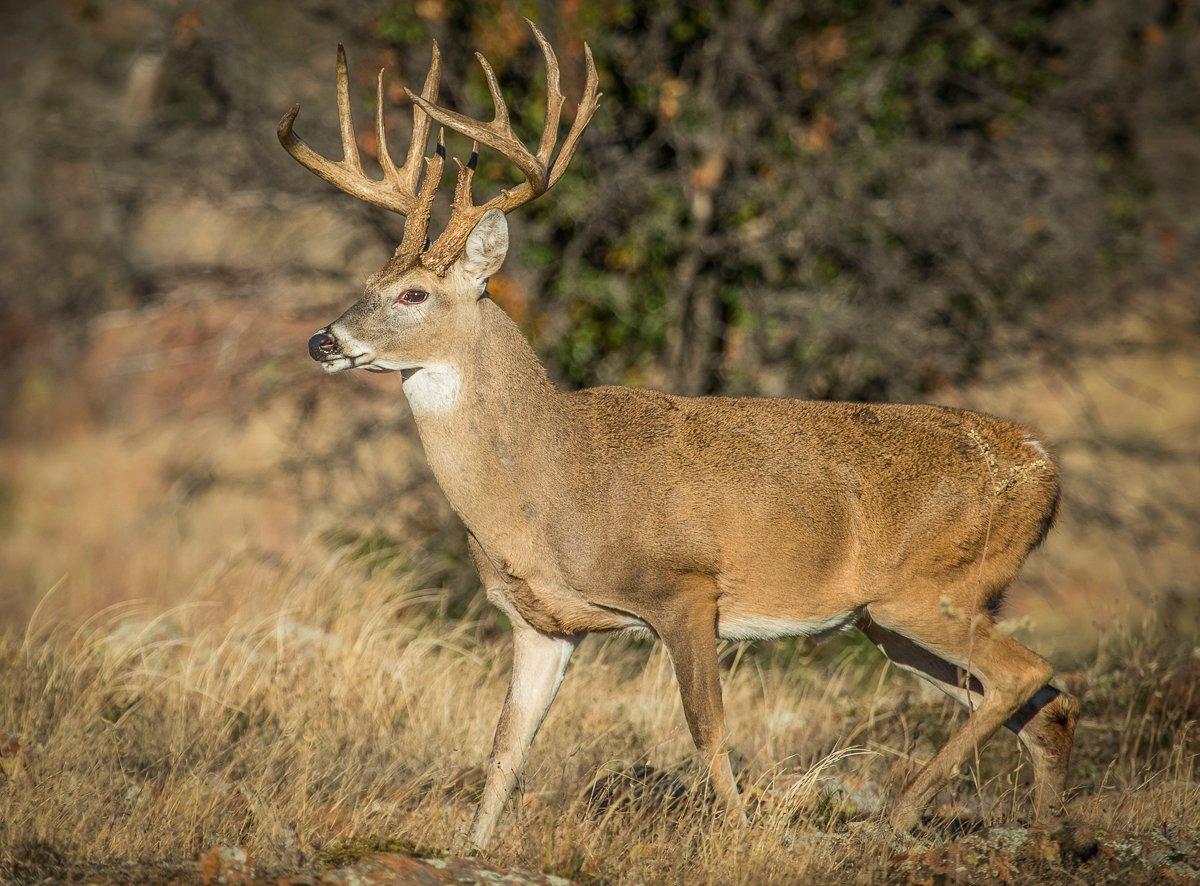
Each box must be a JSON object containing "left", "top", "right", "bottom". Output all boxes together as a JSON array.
[{"left": 278, "top": 19, "right": 600, "bottom": 372}]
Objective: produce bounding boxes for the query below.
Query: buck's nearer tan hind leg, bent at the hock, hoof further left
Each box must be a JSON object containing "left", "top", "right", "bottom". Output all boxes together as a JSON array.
[{"left": 869, "top": 600, "right": 1066, "bottom": 831}]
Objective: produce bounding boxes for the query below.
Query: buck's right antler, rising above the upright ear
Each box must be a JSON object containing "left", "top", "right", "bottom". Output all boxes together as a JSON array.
[{"left": 404, "top": 18, "right": 600, "bottom": 274}]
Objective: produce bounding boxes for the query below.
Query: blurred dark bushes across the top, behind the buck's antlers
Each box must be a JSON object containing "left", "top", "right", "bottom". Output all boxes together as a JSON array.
[{"left": 0, "top": 0, "right": 1200, "bottom": 399}]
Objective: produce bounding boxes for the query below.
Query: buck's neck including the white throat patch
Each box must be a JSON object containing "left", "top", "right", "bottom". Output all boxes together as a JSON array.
[{"left": 404, "top": 301, "right": 571, "bottom": 563}]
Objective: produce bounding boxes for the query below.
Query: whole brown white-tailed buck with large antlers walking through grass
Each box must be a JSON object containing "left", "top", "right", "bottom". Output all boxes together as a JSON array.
[{"left": 278, "top": 22, "right": 1078, "bottom": 848}]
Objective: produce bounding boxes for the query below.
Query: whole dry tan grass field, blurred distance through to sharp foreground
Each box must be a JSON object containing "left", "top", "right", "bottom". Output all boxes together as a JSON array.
[{"left": 0, "top": 290, "right": 1200, "bottom": 884}]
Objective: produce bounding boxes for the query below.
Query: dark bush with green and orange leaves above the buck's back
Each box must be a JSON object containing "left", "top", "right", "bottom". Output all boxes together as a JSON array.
[{"left": 376, "top": 0, "right": 1190, "bottom": 397}]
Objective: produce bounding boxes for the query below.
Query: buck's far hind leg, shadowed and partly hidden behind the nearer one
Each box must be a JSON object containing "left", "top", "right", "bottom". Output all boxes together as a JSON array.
[{"left": 857, "top": 616, "right": 1079, "bottom": 821}]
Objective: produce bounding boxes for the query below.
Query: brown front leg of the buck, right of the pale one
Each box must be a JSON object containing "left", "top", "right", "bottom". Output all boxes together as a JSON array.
[{"left": 652, "top": 589, "right": 744, "bottom": 818}]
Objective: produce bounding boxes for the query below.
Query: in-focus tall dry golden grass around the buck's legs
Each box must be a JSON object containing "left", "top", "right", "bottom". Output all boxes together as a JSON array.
[{"left": 0, "top": 535, "right": 1200, "bottom": 882}]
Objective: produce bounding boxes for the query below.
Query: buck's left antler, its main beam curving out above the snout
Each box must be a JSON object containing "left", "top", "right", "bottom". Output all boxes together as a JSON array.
[{"left": 278, "top": 43, "right": 445, "bottom": 258}]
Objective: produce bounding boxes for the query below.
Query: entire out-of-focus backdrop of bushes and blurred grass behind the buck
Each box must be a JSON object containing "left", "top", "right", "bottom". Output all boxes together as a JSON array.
[{"left": 0, "top": 0, "right": 1200, "bottom": 652}]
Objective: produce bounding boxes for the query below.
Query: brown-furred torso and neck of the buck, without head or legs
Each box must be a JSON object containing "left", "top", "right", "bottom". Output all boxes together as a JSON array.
[{"left": 420, "top": 301, "right": 1058, "bottom": 634}]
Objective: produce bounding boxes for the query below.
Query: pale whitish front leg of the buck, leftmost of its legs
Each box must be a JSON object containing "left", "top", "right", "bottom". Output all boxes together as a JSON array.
[{"left": 468, "top": 613, "right": 581, "bottom": 850}]
